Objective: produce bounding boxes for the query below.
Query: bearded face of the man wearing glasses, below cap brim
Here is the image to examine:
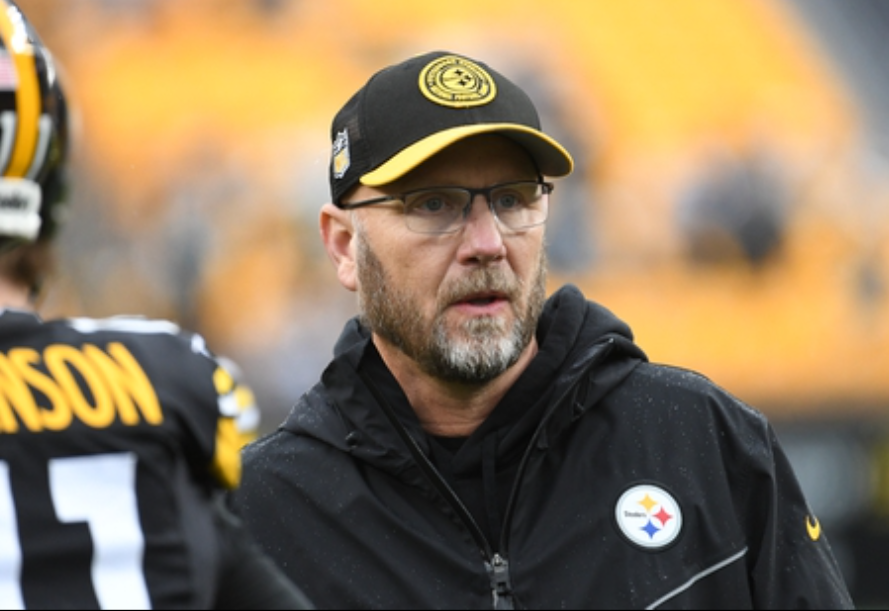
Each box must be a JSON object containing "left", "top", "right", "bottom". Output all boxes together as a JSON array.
[{"left": 349, "top": 136, "right": 546, "bottom": 384}]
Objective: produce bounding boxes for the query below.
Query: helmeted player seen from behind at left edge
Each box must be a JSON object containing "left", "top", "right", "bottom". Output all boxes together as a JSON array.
[{"left": 0, "top": 0, "right": 311, "bottom": 609}]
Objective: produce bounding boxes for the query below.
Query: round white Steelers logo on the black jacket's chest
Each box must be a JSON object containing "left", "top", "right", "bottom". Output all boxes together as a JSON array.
[{"left": 614, "top": 484, "right": 682, "bottom": 549}]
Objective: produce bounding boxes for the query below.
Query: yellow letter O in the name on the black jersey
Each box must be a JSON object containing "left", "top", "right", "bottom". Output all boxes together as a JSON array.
[{"left": 43, "top": 344, "right": 115, "bottom": 429}]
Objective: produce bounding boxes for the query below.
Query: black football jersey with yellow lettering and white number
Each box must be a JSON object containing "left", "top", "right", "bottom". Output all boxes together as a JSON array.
[{"left": 0, "top": 310, "right": 243, "bottom": 609}]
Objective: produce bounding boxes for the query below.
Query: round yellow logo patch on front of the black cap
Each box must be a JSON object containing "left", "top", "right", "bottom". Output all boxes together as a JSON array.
[{"left": 420, "top": 55, "right": 497, "bottom": 108}]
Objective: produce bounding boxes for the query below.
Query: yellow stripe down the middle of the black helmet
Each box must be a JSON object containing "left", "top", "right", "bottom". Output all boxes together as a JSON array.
[{"left": 0, "top": 2, "right": 41, "bottom": 177}]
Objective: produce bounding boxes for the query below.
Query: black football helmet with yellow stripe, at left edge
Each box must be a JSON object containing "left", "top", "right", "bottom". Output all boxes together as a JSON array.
[{"left": 0, "top": 0, "right": 68, "bottom": 241}]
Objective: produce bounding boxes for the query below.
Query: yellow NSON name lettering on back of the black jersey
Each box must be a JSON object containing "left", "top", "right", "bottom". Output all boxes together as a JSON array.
[{"left": 0, "top": 342, "right": 163, "bottom": 434}]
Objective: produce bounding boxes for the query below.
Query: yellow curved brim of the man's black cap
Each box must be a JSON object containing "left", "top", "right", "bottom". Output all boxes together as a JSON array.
[{"left": 361, "top": 123, "right": 574, "bottom": 187}]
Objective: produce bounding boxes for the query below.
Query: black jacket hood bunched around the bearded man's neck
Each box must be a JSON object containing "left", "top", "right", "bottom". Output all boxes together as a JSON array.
[{"left": 280, "top": 285, "right": 646, "bottom": 472}]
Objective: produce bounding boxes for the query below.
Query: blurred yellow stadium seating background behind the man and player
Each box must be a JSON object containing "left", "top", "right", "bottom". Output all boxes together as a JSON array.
[{"left": 19, "top": 0, "right": 889, "bottom": 608}]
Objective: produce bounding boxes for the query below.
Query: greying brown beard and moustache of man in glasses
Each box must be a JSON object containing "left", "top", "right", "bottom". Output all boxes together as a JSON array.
[{"left": 357, "top": 231, "right": 546, "bottom": 385}]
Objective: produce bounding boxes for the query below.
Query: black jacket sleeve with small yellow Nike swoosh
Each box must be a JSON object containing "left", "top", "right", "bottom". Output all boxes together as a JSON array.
[{"left": 747, "top": 422, "right": 854, "bottom": 609}]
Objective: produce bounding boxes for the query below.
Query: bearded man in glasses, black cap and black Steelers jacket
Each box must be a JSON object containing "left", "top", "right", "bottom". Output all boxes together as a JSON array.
[{"left": 234, "top": 52, "right": 852, "bottom": 609}]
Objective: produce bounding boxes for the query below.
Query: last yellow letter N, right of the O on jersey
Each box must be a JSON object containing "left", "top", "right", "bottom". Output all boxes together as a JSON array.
[{"left": 83, "top": 342, "right": 164, "bottom": 426}]
